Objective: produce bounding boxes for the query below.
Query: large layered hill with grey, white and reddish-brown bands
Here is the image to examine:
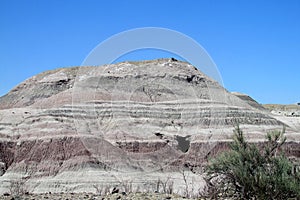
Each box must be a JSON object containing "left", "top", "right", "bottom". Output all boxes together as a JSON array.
[{"left": 0, "top": 59, "right": 300, "bottom": 193}]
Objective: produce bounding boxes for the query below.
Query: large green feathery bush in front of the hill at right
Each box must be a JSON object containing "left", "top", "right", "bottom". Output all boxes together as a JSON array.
[{"left": 206, "top": 127, "right": 300, "bottom": 199}]
